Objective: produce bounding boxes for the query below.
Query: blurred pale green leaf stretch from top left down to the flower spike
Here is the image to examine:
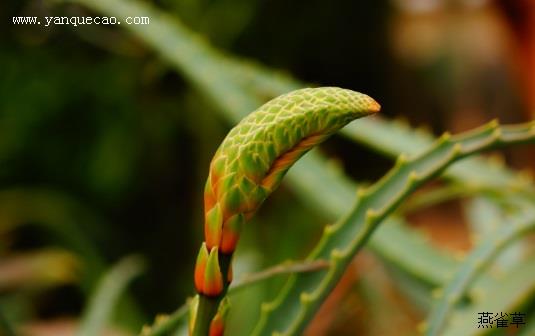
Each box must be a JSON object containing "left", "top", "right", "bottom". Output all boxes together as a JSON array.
[{"left": 55, "top": 0, "right": 261, "bottom": 120}]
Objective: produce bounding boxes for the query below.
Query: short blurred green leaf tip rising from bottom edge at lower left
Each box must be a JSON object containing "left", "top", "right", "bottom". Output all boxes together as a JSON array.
[{"left": 76, "top": 256, "right": 143, "bottom": 336}]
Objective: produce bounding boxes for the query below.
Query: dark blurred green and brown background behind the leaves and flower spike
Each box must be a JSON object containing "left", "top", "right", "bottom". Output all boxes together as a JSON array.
[{"left": 0, "top": 0, "right": 535, "bottom": 335}]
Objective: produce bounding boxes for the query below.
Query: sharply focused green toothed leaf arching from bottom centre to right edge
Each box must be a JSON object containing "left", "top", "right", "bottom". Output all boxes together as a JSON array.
[{"left": 252, "top": 122, "right": 535, "bottom": 335}]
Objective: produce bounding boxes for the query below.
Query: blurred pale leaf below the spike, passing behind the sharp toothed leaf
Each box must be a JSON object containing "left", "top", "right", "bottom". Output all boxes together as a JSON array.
[{"left": 288, "top": 151, "right": 457, "bottom": 286}]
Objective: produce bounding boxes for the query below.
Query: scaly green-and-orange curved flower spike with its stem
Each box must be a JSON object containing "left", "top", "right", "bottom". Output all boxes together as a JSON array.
[{"left": 192, "top": 87, "right": 380, "bottom": 336}]
